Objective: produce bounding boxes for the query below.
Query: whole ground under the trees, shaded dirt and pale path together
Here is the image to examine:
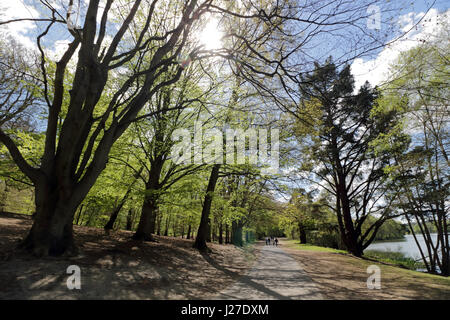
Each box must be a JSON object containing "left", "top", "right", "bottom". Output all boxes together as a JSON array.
[{"left": 0, "top": 213, "right": 450, "bottom": 300}]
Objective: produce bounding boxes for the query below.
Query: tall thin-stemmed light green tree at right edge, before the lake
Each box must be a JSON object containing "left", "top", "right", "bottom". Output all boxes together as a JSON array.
[{"left": 381, "top": 32, "right": 450, "bottom": 276}]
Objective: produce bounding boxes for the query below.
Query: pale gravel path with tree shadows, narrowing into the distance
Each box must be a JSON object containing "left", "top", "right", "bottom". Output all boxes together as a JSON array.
[{"left": 214, "top": 242, "right": 323, "bottom": 300}]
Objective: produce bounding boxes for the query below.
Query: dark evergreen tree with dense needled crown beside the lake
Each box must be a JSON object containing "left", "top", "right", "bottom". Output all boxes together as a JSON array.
[{"left": 296, "top": 60, "right": 406, "bottom": 256}]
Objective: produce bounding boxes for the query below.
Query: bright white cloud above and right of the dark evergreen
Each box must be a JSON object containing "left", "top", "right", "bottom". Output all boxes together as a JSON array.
[{"left": 351, "top": 9, "right": 450, "bottom": 90}]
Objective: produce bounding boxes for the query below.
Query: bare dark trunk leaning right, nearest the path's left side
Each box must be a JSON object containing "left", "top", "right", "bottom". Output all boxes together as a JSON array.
[{"left": 193, "top": 164, "right": 220, "bottom": 250}]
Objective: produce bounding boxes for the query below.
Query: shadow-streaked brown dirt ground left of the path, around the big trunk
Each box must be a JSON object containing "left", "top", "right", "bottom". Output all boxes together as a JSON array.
[{"left": 0, "top": 213, "right": 256, "bottom": 300}]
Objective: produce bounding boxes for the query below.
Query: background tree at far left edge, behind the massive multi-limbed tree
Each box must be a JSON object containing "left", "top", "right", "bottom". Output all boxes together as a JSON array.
[{"left": 0, "top": 34, "right": 43, "bottom": 205}]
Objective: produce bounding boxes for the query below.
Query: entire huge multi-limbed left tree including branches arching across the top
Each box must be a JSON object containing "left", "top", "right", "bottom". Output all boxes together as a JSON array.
[{"left": 0, "top": 0, "right": 414, "bottom": 256}]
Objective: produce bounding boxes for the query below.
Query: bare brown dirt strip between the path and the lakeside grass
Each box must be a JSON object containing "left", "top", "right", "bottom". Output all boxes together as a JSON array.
[{"left": 281, "top": 241, "right": 450, "bottom": 300}]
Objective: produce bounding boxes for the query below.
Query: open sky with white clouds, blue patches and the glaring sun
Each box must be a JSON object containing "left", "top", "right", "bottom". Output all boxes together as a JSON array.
[{"left": 0, "top": 0, "right": 450, "bottom": 88}]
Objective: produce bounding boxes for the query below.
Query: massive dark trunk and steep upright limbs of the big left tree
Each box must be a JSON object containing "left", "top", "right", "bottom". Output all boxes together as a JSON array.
[{"left": 0, "top": 0, "right": 209, "bottom": 255}]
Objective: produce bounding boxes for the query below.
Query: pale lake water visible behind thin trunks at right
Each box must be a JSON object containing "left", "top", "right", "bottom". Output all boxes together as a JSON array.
[{"left": 366, "top": 233, "right": 437, "bottom": 260}]
